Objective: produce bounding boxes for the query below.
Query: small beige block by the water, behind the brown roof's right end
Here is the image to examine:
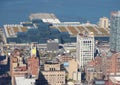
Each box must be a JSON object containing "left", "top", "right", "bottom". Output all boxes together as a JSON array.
[{"left": 99, "top": 17, "right": 109, "bottom": 28}]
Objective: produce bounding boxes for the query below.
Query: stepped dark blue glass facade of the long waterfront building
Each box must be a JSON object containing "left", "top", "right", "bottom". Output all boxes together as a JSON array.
[{"left": 7, "top": 19, "right": 76, "bottom": 43}]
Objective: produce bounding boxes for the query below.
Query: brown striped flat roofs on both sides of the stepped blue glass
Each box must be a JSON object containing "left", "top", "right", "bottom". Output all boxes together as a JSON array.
[{"left": 4, "top": 23, "right": 110, "bottom": 38}]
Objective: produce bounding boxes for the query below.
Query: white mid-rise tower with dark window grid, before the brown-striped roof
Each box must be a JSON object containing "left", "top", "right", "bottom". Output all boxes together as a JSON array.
[{"left": 76, "top": 32, "right": 94, "bottom": 67}]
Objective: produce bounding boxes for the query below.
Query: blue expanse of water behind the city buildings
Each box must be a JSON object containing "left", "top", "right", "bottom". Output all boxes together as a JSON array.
[{"left": 0, "top": 0, "right": 120, "bottom": 26}]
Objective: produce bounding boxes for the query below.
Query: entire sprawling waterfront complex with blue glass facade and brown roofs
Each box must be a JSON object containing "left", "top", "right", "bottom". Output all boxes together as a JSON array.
[{"left": 3, "top": 13, "right": 109, "bottom": 43}]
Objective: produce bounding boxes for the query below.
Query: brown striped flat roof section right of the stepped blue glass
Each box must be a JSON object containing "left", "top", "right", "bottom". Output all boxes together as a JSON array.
[{"left": 51, "top": 23, "right": 110, "bottom": 37}]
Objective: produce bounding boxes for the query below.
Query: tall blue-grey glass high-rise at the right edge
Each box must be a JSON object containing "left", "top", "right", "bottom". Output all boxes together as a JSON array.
[{"left": 110, "top": 11, "right": 120, "bottom": 52}]
